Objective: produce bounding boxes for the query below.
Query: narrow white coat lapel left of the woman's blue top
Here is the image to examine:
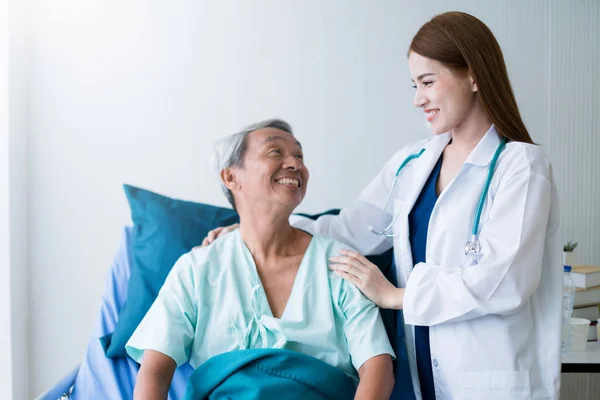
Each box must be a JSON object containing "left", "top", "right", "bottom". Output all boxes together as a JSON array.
[{"left": 394, "top": 133, "right": 451, "bottom": 282}]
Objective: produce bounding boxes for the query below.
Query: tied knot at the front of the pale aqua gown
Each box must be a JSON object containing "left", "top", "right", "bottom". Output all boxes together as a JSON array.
[{"left": 230, "top": 285, "right": 287, "bottom": 350}]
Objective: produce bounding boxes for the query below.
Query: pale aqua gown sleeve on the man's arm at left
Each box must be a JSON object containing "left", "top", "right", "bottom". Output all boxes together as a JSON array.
[{"left": 125, "top": 254, "right": 198, "bottom": 366}]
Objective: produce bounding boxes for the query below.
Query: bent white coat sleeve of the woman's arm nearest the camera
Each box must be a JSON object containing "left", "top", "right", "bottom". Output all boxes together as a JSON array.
[{"left": 404, "top": 165, "right": 552, "bottom": 326}]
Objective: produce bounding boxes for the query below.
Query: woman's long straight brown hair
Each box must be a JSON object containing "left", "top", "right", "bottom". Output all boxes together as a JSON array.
[{"left": 408, "top": 12, "right": 533, "bottom": 143}]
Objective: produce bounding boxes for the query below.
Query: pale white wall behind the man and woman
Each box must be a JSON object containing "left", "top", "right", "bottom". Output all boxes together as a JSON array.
[{"left": 21, "top": 0, "right": 600, "bottom": 397}]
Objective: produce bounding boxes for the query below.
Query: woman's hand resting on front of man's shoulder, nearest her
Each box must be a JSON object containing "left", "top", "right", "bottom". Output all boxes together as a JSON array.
[{"left": 329, "top": 250, "right": 404, "bottom": 310}]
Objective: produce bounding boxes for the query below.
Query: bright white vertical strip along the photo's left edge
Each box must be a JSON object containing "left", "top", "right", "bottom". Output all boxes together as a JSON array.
[{"left": 0, "top": 1, "right": 29, "bottom": 399}]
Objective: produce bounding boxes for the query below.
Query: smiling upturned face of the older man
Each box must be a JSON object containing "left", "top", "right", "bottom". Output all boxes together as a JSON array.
[{"left": 234, "top": 128, "right": 309, "bottom": 214}]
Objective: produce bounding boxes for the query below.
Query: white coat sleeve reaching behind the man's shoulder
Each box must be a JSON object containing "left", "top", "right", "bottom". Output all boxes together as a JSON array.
[{"left": 290, "top": 143, "right": 421, "bottom": 255}]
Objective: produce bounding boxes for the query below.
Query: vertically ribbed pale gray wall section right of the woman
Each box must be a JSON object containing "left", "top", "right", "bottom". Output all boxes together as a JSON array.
[{"left": 538, "top": 0, "right": 600, "bottom": 265}]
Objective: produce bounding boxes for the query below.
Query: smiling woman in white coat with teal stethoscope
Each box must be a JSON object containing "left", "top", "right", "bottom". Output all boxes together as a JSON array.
[{"left": 205, "top": 12, "right": 562, "bottom": 400}]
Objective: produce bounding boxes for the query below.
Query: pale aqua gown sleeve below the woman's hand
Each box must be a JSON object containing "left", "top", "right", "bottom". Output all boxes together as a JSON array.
[{"left": 339, "top": 278, "right": 395, "bottom": 371}]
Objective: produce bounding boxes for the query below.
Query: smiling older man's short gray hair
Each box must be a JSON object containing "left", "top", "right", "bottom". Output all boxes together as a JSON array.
[{"left": 213, "top": 119, "right": 294, "bottom": 210}]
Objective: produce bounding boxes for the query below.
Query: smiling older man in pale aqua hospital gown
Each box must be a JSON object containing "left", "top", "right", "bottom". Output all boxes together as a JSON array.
[{"left": 126, "top": 120, "right": 394, "bottom": 399}]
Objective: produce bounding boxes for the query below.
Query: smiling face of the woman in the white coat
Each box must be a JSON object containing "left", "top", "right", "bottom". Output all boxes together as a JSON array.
[{"left": 408, "top": 52, "right": 478, "bottom": 135}]
